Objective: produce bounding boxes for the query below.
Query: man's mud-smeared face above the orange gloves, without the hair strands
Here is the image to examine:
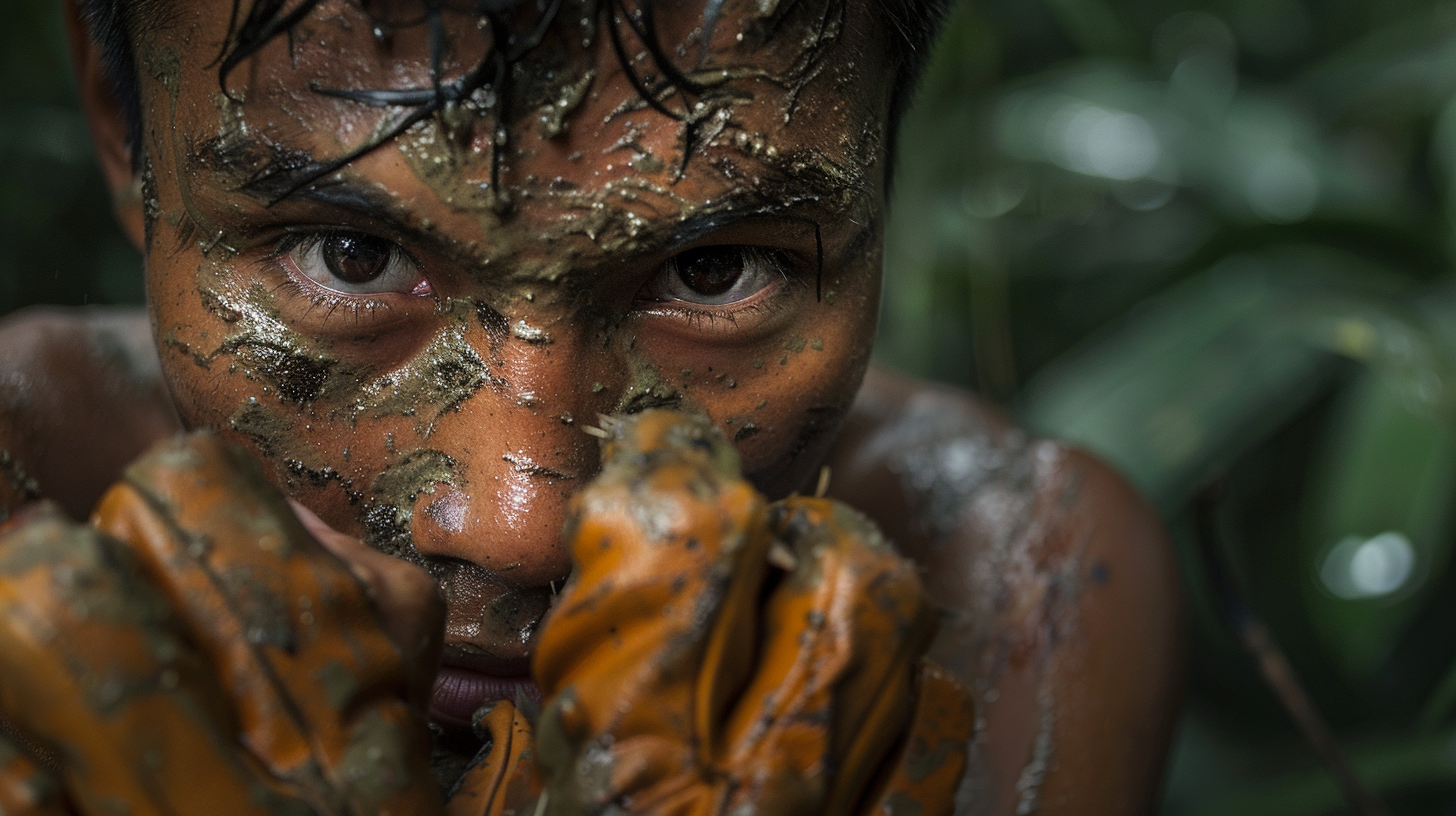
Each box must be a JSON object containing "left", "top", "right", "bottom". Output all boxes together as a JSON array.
[{"left": 137, "top": 0, "right": 891, "bottom": 723}]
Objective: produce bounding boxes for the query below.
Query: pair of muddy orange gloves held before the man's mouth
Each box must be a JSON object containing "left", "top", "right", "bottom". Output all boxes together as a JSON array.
[{"left": 0, "top": 411, "right": 974, "bottom": 816}]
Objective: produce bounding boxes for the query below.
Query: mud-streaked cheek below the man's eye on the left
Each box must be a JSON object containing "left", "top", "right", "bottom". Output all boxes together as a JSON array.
[{"left": 147, "top": 244, "right": 436, "bottom": 533}]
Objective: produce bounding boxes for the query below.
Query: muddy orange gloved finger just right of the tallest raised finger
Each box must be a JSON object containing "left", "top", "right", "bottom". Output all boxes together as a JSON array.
[{"left": 727, "top": 497, "right": 935, "bottom": 813}]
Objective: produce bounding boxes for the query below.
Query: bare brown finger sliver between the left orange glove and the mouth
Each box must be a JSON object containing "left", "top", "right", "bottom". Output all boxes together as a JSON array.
[{"left": 288, "top": 498, "right": 446, "bottom": 707}]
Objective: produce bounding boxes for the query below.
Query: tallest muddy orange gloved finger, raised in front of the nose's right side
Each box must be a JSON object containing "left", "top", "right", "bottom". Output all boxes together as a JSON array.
[{"left": 533, "top": 411, "right": 769, "bottom": 803}]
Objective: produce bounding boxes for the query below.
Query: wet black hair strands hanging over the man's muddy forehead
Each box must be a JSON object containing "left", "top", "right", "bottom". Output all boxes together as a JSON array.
[{"left": 180, "top": 0, "right": 846, "bottom": 214}]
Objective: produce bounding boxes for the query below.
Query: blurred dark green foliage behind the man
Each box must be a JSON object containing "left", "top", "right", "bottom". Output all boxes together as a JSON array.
[{"left": 8, "top": 0, "right": 1456, "bottom": 816}]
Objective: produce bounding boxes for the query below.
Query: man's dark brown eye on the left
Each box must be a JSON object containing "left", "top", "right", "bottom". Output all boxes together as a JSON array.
[{"left": 278, "top": 230, "right": 431, "bottom": 294}]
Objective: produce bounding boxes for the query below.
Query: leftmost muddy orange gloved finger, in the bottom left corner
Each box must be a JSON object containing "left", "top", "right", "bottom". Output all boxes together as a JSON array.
[{"left": 0, "top": 506, "right": 304, "bottom": 816}]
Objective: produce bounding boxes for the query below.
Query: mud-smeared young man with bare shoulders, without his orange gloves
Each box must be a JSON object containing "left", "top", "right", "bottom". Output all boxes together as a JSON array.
[{"left": 0, "top": 0, "right": 1179, "bottom": 815}]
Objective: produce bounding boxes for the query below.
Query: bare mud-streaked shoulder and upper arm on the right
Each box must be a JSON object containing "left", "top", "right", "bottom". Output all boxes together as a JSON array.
[{"left": 830, "top": 370, "right": 1182, "bottom": 815}]
